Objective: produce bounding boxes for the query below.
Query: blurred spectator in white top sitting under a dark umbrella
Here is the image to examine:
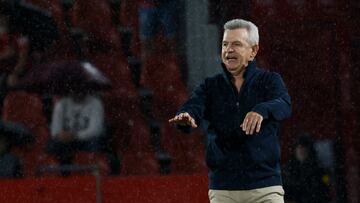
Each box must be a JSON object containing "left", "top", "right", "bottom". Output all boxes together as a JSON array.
[{"left": 47, "top": 93, "right": 106, "bottom": 175}]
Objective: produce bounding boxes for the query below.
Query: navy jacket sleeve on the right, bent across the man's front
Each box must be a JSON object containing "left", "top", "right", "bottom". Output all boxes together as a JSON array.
[{"left": 252, "top": 73, "right": 291, "bottom": 121}]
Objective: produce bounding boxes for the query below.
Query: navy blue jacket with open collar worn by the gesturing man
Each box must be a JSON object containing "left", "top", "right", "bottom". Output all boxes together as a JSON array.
[{"left": 178, "top": 61, "right": 291, "bottom": 190}]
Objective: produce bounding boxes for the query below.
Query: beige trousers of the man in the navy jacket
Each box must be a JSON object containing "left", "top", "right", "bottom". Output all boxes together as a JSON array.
[{"left": 209, "top": 186, "right": 285, "bottom": 203}]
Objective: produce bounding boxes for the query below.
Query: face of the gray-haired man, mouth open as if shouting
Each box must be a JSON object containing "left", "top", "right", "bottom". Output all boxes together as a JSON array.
[{"left": 221, "top": 28, "right": 258, "bottom": 76}]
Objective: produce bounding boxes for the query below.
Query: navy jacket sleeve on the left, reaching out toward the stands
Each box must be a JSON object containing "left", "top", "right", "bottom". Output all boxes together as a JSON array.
[{"left": 176, "top": 81, "right": 208, "bottom": 132}]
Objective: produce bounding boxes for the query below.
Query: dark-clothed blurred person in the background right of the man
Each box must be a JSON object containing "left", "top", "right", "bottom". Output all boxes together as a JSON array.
[{"left": 283, "top": 134, "right": 329, "bottom": 203}]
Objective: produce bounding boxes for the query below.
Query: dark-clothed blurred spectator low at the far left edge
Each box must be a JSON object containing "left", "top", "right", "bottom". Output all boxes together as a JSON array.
[{"left": 0, "top": 129, "right": 22, "bottom": 178}]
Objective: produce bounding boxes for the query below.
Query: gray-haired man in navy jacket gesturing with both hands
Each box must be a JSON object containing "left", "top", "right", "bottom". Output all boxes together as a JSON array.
[{"left": 169, "top": 19, "right": 291, "bottom": 203}]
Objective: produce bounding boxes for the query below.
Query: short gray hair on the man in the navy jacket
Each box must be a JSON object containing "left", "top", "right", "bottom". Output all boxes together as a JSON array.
[{"left": 224, "top": 19, "right": 259, "bottom": 46}]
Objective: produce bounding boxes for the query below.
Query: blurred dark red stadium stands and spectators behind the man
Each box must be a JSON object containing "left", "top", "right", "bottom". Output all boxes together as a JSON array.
[{"left": 0, "top": 0, "right": 360, "bottom": 203}]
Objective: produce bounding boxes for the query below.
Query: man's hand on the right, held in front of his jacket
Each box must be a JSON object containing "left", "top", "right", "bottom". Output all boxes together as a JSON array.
[{"left": 240, "top": 112, "right": 263, "bottom": 135}]
